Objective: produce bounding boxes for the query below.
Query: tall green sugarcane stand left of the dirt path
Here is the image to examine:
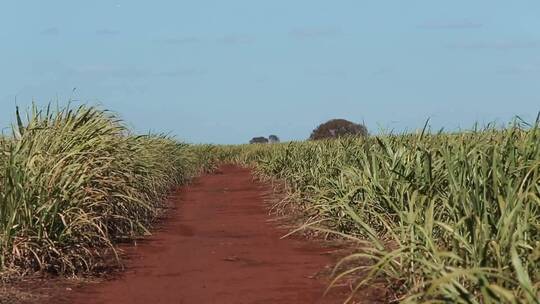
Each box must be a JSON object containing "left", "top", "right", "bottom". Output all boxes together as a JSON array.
[{"left": 0, "top": 106, "right": 209, "bottom": 273}]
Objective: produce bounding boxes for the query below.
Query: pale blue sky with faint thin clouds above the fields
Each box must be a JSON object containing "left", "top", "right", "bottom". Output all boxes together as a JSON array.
[{"left": 0, "top": 0, "right": 540, "bottom": 144}]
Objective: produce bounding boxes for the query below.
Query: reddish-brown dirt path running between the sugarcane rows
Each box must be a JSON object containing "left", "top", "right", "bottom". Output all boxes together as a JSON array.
[{"left": 65, "top": 166, "right": 350, "bottom": 304}]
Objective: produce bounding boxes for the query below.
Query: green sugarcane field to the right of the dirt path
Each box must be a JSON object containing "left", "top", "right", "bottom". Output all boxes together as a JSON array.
[{"left": 227, "top": 123, "right": 540, "bottom": 303}]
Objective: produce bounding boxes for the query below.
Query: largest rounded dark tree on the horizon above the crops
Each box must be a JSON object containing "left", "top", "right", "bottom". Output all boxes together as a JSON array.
[{"left": 309, "top": 119, "right": 368, "bottom": 140}]
